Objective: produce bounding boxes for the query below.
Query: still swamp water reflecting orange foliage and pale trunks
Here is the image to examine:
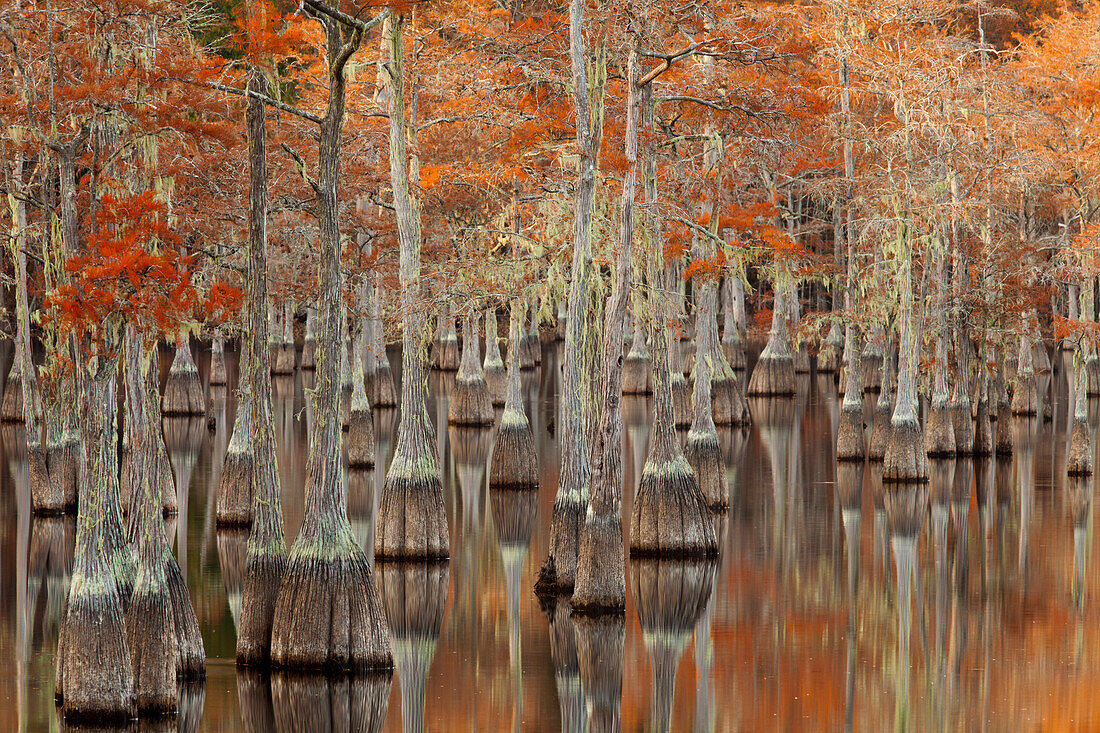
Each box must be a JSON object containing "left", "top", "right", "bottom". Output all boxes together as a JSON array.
[{"left": 0, "top": 347, "right": 1100, "bottom": 731}]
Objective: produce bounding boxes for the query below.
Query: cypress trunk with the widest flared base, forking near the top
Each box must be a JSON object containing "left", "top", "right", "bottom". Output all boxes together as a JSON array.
[{"left": 271, "top": 14, "right": 393, "bottom": 670}]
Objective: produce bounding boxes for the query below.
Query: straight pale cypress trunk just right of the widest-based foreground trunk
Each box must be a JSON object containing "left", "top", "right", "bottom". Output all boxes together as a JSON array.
[{"left": 374, "top": 15, "right": 450, "bottom": 559}]
